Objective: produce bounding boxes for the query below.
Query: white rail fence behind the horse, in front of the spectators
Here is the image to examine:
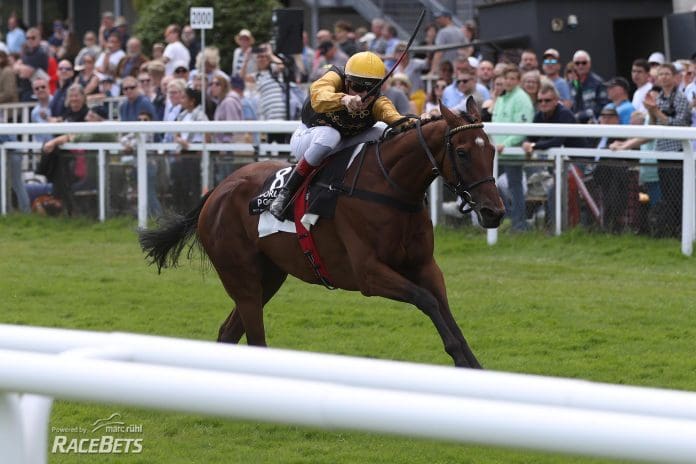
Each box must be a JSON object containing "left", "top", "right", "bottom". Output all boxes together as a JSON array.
[{"left": 0, "top": 121, "right": 696, "bottom": 256}]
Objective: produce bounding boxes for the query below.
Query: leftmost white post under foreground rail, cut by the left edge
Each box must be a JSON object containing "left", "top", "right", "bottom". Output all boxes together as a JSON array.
[{"left": 0, "top": 393, "right": 25, "bottom": 464}]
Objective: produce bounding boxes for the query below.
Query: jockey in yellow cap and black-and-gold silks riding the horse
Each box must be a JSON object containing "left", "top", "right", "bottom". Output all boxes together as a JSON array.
[{"left": 268, "top": 52, "right": 414, "bottom": 221}]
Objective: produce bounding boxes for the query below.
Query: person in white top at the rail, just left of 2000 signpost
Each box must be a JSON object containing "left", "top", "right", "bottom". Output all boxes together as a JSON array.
[{"left": 171, "top": 88, "right": 208, "bottom": 211}]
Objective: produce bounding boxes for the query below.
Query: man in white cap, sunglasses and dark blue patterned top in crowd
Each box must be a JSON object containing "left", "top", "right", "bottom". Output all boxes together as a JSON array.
[{"left": 570, "top": 50, "right": 607, "bottom": 122}]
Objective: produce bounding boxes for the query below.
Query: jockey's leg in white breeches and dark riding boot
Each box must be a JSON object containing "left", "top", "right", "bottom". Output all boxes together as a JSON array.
[{"left": 268, "top": 126, "right": 341, "bottom": 221}]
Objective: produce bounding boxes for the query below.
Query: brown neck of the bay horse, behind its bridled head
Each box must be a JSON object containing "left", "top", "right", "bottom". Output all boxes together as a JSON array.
[{"left": 382, "top": 120, "right": 447, "bottom": 198}]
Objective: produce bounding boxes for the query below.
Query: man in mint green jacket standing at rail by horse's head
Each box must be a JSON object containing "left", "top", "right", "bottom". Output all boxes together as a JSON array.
[{"left": 493, "top": 66, "right": 534, "bottom": 232}]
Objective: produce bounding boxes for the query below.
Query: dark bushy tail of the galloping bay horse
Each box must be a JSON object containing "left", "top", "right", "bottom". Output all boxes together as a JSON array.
[{"left": 138, "top": 190, "right": 213, "bottom": 273}]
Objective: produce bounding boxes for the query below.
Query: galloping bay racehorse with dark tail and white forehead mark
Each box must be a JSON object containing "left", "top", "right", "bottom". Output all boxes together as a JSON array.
[{"left": 140, "top": 98, "right": 505, "bottom": 368}]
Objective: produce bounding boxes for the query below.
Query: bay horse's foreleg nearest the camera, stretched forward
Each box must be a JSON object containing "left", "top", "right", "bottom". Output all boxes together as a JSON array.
[{"left": 356, "top": 260, "right": 480, "bottom": 367}]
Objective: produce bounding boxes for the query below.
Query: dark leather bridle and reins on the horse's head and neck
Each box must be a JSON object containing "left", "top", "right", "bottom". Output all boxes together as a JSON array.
[{"left": 376, "top": 118, "right": 495, "bottom": 214}]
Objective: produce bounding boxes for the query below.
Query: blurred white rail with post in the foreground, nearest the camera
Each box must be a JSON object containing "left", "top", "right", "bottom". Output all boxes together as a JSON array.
[{"left": 0, "top": 325, "right": 696, "bottom": 464}]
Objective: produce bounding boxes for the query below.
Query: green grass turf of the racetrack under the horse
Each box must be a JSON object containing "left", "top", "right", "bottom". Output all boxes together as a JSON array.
[{"left": 0, "top": 216, "right": 696, "bottom": 464}]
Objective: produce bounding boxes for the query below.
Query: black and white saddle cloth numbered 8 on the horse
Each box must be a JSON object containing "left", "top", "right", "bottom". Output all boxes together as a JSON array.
[{"left": 254, "top": 143, "right": 365, "bottom": 238}]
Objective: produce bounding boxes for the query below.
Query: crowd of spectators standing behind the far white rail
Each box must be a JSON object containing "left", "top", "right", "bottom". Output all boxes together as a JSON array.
[{"left": 0, "top": 10, "right": 696, "bottom": 236}]
